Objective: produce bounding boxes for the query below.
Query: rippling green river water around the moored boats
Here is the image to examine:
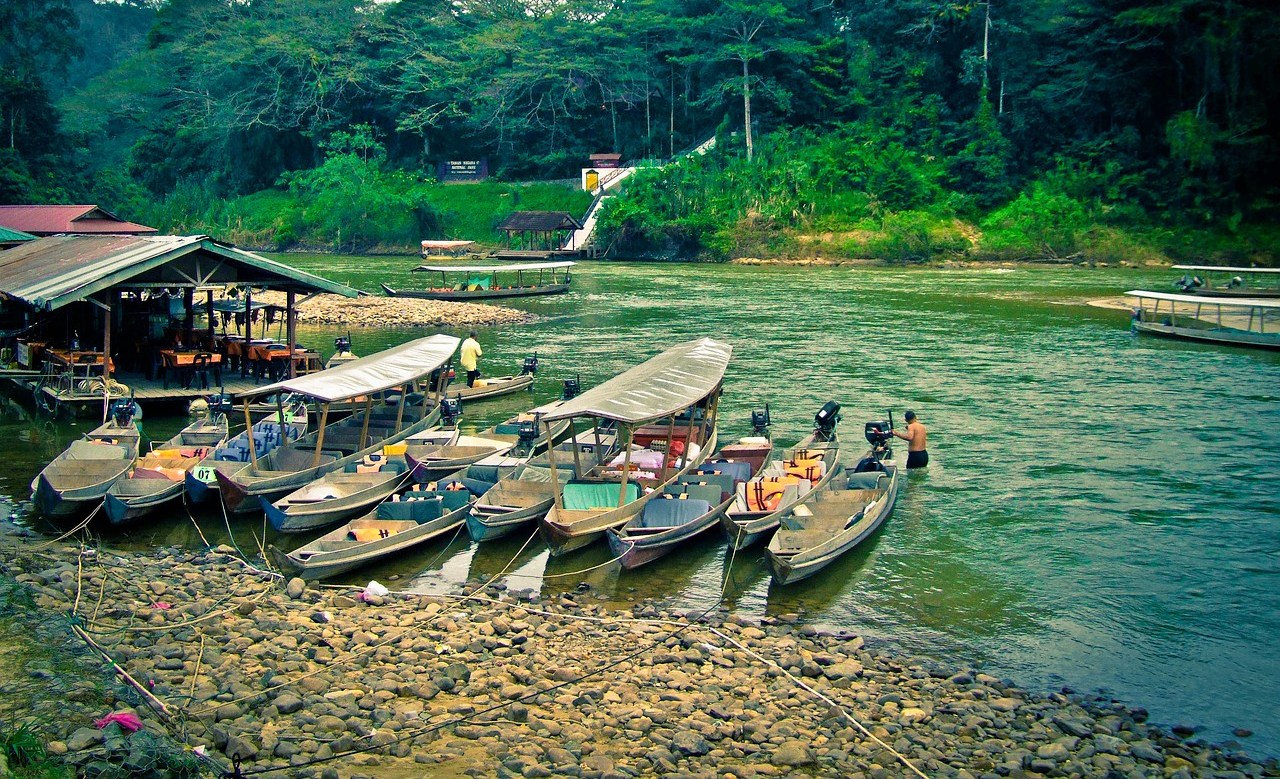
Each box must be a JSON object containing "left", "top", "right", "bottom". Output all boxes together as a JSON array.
[{"left": 0, "top": 256, "right": 1280, "bottom": 755}]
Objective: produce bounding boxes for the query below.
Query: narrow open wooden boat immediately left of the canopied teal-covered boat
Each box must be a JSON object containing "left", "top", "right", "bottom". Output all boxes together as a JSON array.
[{"left": 467, "top": 427, "right": 617, "bottom": 541}]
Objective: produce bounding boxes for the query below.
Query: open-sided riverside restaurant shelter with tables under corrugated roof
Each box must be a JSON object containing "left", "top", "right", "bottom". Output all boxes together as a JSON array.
[{"left": 0, "top": 234, "right": 358, "bottom": 402}]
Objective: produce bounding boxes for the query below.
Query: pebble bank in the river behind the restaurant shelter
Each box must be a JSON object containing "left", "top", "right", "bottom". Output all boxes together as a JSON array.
[{"left": 253, "top": 292, "right": 534, "bottom": 329}]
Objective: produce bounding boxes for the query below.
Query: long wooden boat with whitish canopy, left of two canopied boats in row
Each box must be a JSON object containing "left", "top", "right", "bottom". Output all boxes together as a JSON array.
[{"left": 216, "top": 334, "right": 460, "bottom": 513}]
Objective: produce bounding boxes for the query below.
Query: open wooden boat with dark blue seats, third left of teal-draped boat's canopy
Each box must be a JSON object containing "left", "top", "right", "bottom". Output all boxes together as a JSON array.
[{"left": 268, "top": 471, "right": 490, "bottom": 579}]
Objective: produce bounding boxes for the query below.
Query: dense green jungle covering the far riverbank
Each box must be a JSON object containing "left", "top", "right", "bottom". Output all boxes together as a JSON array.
[{"left": 0, "top": 0, "right": 1280, "bottom": 262}]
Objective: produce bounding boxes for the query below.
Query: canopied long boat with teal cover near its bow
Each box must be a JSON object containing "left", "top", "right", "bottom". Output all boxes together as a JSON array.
[{"left": 539, "top": 338, "right": 733, "bottom": 556}]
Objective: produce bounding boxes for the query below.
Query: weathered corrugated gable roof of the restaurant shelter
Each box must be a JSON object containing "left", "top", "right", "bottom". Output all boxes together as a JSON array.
[{"left": 0, "top": 235, "right": 360, "bottom": 311}]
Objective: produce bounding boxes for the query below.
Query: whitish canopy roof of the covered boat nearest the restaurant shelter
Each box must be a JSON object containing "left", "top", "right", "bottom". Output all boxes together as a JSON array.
[{"left": 241, "top": 334, "right": 460, "bottom": 403}]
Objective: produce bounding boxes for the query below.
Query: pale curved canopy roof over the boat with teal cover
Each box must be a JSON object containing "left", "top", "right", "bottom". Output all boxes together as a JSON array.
[{"left": 543, "top": 338, "right": 733, "bottom": 425}]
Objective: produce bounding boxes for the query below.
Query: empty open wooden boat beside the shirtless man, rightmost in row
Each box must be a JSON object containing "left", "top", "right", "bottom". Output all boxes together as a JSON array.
[{"left": 765, "top": 422, "right": 899, "bottom": 585}]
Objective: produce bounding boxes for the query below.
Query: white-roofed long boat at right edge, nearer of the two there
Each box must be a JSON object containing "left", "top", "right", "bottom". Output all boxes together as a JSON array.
[{"left": 1125, "top": 289, "right": 1280, "bottom": 349}]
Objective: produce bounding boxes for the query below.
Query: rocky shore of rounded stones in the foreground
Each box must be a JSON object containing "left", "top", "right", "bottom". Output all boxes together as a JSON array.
[{"left": 0, "top": 533, "right": 1280, "bottom": 779}]
